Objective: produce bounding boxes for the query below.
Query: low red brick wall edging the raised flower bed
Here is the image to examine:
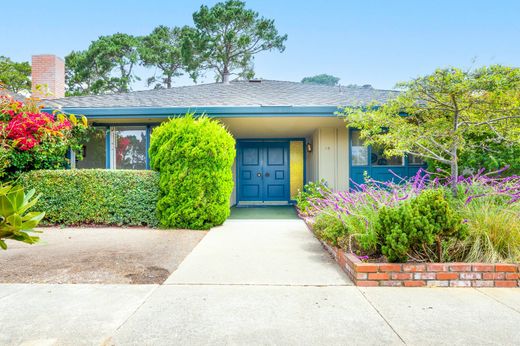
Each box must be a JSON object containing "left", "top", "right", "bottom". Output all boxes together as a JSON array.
[{"left": 320, "top": 234, "right": 520, "bottom": 287}]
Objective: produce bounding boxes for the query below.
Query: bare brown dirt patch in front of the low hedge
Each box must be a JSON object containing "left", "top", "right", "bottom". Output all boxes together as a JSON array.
[{"left": 0, "top": 228, "right": 206, "bottom": 284}]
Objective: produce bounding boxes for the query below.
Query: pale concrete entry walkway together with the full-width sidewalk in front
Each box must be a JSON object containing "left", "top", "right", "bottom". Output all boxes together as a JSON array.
[{"left": 0, "top": 220, "right": 520, "bottom": 345}]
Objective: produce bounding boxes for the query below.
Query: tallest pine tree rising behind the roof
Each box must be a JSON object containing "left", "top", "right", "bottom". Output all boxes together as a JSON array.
[{"left": 193, "top": 0, "right": 287, "bottom": 82}]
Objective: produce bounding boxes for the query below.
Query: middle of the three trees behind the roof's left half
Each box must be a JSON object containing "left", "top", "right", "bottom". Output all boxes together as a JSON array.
[{"left": 139, "top": 25, "right": 196, "bottom": 89}]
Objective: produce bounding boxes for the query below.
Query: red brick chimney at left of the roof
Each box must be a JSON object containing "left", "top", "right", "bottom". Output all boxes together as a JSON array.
[{"left": 32, "top": 54, "right": 65, "bottom": 99}]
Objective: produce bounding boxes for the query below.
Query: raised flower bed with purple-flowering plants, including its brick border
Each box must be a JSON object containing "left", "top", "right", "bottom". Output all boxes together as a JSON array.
[{"left": 297, "top": 171, "right": 520, "bottom": 287}]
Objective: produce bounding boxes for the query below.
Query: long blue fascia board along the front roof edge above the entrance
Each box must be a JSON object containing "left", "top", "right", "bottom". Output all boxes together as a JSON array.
[{"left": 44, "top": 106, "right": 340, "bottom": 119}]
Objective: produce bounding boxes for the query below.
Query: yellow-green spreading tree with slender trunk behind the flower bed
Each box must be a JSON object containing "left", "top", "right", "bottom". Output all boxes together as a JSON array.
[{"left": 342, "top": 65, "right": 520, "bottom": 194}]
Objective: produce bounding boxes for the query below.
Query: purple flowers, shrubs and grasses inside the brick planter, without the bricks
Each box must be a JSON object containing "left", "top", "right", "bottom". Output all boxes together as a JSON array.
[{"left": 298, "top": 170, "right": 520, "bottom": 262}]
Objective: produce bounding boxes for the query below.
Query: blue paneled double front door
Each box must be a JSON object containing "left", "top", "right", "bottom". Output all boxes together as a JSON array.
[{"left": 237, "top": 141, "right": 289, "bottom": 202}]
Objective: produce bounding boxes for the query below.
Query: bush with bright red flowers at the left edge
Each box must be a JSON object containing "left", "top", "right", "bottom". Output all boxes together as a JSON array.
[{"left": 0, "top": 89, "right": 88, "bottom": 180}]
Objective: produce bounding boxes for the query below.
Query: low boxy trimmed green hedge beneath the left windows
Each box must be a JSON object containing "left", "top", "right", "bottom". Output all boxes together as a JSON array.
[{"left": 20, "top": 169, "right": 159, "bottom": 226}]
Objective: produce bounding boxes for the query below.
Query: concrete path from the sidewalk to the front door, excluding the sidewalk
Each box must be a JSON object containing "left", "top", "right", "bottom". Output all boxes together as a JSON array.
[{"left": 165, "top": 219, "right": 352, "bottom": 286}]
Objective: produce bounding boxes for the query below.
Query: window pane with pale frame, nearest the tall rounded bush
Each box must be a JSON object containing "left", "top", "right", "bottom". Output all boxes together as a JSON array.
[{"left": 112, "top": 126, "right": 146, "bottom": 169}]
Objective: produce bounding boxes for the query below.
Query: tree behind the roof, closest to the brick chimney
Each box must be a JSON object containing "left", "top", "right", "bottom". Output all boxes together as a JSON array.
[{"left": 65, "top": 33, "right": 141, "bottom": 95}]
